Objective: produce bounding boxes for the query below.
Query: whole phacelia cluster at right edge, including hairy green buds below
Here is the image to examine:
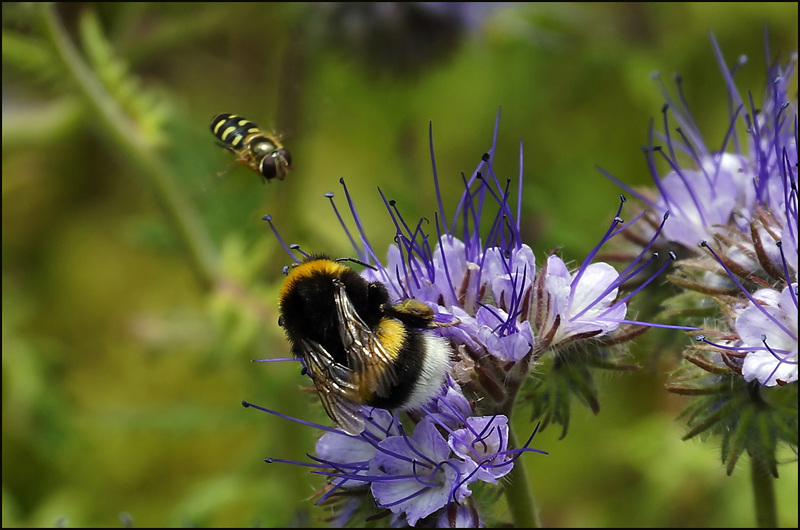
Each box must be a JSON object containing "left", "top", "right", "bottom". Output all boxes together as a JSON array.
[{"left": 608, "top": 36, "right": 798, "bottom": 476}]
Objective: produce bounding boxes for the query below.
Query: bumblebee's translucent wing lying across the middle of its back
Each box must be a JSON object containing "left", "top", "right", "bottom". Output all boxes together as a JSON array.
[{"left": 333, "top": 281, "right": 400, "bottom": 397}]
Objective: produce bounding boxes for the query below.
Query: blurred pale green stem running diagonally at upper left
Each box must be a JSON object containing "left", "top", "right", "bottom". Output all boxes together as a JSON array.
[{"left": 39, "top": 3, "right": 218, "bottom": 289}]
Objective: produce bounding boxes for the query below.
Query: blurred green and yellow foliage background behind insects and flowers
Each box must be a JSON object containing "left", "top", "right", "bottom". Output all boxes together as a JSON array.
[{"left": 2, "top": 3, "right": 798, "bottom": 527}]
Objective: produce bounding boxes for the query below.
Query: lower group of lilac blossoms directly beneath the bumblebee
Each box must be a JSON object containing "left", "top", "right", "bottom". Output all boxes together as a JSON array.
[{"left": 243, "top": 372, "right": 546, "bottom": 526}]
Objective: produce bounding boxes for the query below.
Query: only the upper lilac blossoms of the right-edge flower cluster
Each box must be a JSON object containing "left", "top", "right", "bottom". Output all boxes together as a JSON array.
[{"left": 600, "top": 36, "right": 798, "bottom": 281}]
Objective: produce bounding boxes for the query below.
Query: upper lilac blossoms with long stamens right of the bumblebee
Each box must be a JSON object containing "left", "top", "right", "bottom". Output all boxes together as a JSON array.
[{"left": 328, "top": 114, "right": 674, "bottom": 396}]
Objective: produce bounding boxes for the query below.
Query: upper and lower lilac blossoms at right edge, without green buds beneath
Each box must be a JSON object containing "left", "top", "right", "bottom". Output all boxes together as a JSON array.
[{"left": 607, "top": 36, "right": 798, "bottom": 386}]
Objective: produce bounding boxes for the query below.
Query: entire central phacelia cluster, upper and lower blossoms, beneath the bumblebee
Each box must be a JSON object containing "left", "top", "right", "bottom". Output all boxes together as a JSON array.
[{"left": 250, "top": 109, "right": 675, "bottom": 526}]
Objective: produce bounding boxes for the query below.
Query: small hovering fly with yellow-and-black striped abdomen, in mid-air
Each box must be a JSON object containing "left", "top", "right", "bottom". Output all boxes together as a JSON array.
[{"left": 211, "top": 114, "right": 292, "bottom": 182}]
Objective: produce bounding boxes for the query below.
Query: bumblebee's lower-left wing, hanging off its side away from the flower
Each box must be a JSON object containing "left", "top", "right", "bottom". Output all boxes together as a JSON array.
[{"left": 300, "top": 340, "right": 364, "bottom": 435}]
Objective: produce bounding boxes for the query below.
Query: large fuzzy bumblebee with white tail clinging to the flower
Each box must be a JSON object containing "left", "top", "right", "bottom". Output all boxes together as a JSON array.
[{"left": 278, "top": 255, "right": 458, "bottom": 435}]
